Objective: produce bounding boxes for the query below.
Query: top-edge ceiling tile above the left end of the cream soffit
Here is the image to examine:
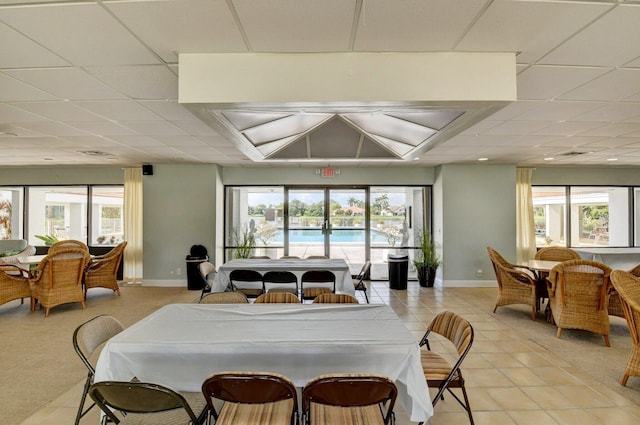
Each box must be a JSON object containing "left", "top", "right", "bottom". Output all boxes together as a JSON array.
[{"left": 105, "top": 0, "right": 247, "bottom": 62}]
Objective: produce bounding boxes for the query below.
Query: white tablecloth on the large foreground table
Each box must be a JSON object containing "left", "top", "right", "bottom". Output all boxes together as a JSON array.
[{"left": 95, "top": 304, "right": 433, "bottom": 421}]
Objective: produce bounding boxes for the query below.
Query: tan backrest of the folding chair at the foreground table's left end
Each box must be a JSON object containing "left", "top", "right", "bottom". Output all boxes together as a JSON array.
[{"left": 72, "top": 314, "right": 124, "bottom": 374}]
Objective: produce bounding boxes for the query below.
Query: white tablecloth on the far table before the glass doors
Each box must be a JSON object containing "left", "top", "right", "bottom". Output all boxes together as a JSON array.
[{"left": 211, "top": 258, "right": 355, "bottom": 295}]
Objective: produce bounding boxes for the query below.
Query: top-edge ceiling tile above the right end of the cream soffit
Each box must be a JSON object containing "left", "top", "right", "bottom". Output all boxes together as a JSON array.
[{"left": 456, "top": 0, "right": 610, "bottom": 63}]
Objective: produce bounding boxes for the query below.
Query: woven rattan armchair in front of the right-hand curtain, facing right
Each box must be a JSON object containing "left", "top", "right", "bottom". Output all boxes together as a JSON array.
[{"left": 487, "top": 247, "right": 538, "bottom": 320}]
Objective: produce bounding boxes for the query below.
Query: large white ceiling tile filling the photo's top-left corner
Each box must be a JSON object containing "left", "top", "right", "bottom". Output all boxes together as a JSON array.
[{"left": 0, "top": 3, "right": 159, "bottom": 65}]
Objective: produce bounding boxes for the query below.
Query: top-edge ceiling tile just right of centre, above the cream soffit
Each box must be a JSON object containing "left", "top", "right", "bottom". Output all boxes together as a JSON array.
[{"left": 354, "top": 0, "right": 486, "bottom": 52}]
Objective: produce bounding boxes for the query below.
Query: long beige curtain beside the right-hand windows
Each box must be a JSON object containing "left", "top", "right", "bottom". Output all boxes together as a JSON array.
[{"left": 516, "top": 168, "right": 536, "bottom": 263}]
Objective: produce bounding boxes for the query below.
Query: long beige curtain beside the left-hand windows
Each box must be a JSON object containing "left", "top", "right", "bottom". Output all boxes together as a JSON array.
[{"left": 123, "top": 168, "right": 142, "bottom": 283}]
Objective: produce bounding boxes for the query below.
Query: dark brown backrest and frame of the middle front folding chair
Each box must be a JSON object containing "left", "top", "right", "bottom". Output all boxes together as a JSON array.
[{"left": 202, "top": 372, "right": 298, "bottom": 423}]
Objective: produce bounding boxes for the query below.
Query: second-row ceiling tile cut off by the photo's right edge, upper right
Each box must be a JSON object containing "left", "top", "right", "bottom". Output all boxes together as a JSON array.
[{"left": 559, "top": 70, "right": 640, "bottom": 101}]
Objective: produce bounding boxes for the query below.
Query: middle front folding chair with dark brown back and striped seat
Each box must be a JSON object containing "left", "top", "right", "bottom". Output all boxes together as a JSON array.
[{"left": 202, "top": 372, "right": 298, "bottom": 425}]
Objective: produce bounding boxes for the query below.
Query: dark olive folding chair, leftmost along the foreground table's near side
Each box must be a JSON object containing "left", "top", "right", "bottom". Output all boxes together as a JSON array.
[{"left": 89, "top": 380, "right": 208, "bottom": 425}]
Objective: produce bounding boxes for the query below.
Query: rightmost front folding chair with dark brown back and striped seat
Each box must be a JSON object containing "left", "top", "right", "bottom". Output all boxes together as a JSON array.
[{"left": 302, "top": 374, "right": 398, "bottom": 425}]
